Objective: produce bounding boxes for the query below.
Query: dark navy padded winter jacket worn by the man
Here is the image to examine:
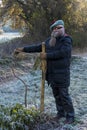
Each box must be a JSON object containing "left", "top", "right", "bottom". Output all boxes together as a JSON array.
[{"left": 24, "top": 35, "right": 72, "bottom": 87}]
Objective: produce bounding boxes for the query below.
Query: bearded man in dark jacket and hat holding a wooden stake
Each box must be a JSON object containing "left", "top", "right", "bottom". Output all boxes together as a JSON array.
[{"left": 15, "top": 20, "right": 74, "bottom": 123}]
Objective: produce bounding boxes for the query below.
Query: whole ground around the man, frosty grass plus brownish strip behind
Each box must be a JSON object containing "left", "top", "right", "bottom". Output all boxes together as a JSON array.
[{"left": 0, "top": 52, "right": 87, "bottom": 130}]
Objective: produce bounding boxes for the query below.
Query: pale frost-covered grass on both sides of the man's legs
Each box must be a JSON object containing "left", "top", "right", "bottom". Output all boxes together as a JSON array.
[{"left": 0, "top": 57, "right": 87, "bottom": 130}]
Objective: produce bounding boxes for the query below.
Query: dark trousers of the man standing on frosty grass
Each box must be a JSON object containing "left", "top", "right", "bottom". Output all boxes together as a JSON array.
[{"left": 52, "top": 86, "right": 74, "bottom": 118}]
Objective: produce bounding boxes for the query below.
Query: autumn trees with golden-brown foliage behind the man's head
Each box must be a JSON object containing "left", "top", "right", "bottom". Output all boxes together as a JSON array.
[{"left": 0, "top": 0, "right": 87, "bottom": 47}]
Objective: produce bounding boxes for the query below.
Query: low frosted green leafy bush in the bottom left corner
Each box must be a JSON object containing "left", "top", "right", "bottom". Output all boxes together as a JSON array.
[{"left": 0, "top": 104, "right": 41, "bottom": 130}]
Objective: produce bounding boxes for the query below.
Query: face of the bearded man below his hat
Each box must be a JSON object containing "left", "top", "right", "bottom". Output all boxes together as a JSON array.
[{"left": 53, "top": 25, "right": 65, "bottom": 37}]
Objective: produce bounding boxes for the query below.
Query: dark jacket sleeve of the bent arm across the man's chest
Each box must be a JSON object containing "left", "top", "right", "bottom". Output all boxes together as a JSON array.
[{"left": 47, "top": 37, "right": 72, "bottom": 60}]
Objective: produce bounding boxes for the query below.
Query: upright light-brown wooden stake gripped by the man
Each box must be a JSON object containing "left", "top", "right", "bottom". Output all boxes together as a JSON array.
[{"left": 40, "top": 42, "right": 46, "bottom": 112}]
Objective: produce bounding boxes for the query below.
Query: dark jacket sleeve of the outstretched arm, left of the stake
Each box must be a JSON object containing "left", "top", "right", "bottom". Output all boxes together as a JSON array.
[{"left": 23, "top": 43, "right": 42, "bottom": 53}]
